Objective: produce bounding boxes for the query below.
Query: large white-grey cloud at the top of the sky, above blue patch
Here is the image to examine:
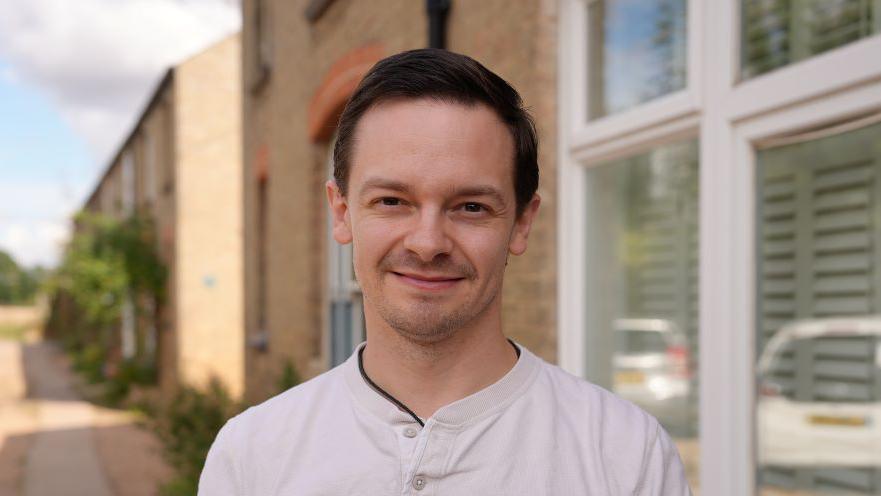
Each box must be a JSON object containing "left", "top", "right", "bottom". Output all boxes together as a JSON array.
[{"left": 0, "top": 0, "right": 241, "bottom": 163}]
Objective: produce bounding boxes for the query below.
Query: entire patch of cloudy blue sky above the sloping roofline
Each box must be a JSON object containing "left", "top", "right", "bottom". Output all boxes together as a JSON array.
[{"left": 0, "top": 0, "right": 241, "bottom": 266}]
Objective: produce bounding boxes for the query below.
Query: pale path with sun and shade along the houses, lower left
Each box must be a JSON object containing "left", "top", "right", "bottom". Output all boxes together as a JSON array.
[{"left": 0, "top": 340, "right": 170, "bottom": 496}]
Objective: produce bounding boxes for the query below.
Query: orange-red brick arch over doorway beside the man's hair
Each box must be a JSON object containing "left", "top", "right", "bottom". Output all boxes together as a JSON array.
[{"left": 309, "top": 43, "right": 385, "bottom": 142}]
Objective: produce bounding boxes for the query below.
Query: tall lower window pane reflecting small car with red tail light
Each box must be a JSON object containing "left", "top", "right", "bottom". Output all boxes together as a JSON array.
[{"left": 585, "top": 141, "right": 700, "bottom": 488}]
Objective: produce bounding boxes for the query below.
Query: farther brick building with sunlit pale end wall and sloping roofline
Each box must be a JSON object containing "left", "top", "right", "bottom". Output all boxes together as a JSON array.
[{"left": 84, "top": 34, "right": 244, "bottom": 396}]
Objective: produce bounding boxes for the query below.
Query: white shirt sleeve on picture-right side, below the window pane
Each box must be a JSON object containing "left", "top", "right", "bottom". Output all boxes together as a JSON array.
[{"left": 636, "top": 425, "right": 691, "bottom": 496}]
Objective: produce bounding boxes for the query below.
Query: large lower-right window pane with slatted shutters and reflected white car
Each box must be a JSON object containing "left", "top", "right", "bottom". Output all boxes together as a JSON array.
[{"left": 756, "top": 119, "right": 881, "bottom": 495}]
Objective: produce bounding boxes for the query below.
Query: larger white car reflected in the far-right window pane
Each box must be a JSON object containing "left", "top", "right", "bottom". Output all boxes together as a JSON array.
[{"left": 756, "top": 316, "right": 881, "bottom": 468}]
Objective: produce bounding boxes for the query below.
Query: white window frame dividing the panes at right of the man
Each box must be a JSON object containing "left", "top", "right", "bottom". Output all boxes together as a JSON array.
[{"left": 557, "top": 0, "right": 881, "bottom": 496}]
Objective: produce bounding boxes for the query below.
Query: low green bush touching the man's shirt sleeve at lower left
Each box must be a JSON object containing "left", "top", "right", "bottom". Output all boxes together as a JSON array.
[{"left": 156, "top": 380, "right": 241, "bottom": 496}]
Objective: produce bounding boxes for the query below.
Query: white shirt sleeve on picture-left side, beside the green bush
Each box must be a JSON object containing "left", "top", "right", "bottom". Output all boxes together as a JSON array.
[{"left": 198, "top": 418, "right": 244, "bottom": 496}]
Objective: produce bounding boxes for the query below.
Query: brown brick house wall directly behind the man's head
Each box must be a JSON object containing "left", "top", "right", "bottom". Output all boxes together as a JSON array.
[{"left": 243, "top": 0, "right": 557, "bottom": 400}]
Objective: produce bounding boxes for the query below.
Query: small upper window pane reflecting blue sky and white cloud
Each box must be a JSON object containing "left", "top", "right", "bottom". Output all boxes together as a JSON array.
[{"left": 588, "top": 0, "right": 687, "bottom": 119}]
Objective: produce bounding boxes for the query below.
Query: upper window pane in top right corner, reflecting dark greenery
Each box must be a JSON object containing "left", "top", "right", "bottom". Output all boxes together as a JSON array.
[{"left": 741, "top": 0, "right": 881, "bottom": 79}]
